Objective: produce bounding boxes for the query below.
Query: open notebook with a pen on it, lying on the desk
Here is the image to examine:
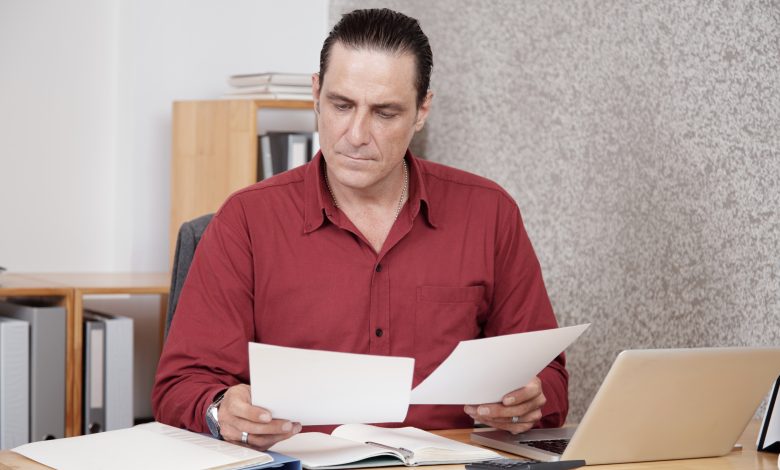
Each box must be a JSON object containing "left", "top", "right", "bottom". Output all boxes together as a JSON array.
[{"left": 271, "top": 424, "right": 500, "bottom": 470}]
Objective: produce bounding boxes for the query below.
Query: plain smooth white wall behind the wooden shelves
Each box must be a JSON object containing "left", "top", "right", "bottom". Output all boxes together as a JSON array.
[{"left": 0, "top": 0, "right": 328, "bottom": 272}]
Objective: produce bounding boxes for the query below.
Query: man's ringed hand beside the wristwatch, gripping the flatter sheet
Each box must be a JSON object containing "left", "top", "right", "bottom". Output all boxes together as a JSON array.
[{"left": 218, "top": 384, "right": 301, "bottom": 450}]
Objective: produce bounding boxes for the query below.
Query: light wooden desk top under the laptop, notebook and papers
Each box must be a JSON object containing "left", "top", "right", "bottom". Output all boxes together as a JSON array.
[{"left": 0, "top": 421, "right": 777, "bottom": 470}]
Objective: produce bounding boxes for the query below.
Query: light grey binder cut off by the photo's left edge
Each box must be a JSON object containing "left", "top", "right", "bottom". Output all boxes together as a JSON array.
[{"left": 0, "top": 317, "right": 30, "bottom": 449}]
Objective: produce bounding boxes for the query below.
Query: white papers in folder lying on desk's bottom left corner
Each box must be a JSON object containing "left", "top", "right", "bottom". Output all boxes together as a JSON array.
[{"left": 12, "top": 422, "right": 300, "bottom": 470}]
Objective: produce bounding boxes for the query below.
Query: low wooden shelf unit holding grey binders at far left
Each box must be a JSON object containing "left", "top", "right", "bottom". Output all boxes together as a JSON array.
[{"left": 0, "top": 273, "right": 171, "bottom": 436}]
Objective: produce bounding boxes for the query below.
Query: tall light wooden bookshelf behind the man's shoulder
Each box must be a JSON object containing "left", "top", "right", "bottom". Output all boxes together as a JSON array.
[{"left": 169, "top": 100, "right": 314, "bottom": 260}]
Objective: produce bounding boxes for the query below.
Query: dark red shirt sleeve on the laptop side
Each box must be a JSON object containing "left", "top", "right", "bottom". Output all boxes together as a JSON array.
[{"left": 483, "top": 196, "right": 569, "bottom": 427}]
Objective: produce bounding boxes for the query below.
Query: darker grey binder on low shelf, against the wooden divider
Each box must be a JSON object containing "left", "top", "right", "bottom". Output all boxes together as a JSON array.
[{"left": 0, "top": 297, "right": 66, "bottom": 442}]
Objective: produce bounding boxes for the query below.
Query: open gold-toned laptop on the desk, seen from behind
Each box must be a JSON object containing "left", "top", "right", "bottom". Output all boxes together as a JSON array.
[{"left": 471, "top": 348, "right": 780, "bottom": 465}]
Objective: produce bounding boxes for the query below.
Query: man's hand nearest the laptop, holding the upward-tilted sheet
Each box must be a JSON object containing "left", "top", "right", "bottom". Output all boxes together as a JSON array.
[{"left": 463, "top": 377, "right": 547, "bottom": 434}]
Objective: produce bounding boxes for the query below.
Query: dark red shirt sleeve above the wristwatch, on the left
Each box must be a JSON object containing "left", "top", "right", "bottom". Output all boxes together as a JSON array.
[{"left": 152, "top": 199, "right": 254, "bottom": 432}]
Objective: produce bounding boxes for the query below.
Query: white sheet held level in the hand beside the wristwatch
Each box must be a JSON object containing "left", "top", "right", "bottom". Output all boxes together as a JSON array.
[{"left": 249, "top": 343, "right": 414, "bottom": 425}]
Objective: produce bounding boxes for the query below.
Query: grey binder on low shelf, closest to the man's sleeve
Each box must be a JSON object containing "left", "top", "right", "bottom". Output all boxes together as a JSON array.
[{"left": 84, "top": 311, "right": 133, "bottom": 434}]
